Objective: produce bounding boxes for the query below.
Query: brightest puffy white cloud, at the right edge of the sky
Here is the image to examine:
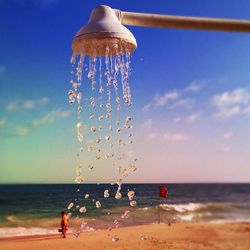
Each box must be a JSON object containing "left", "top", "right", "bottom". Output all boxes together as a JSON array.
[{"left": 211, "top": 88, "right": 250, "bottom": 119}]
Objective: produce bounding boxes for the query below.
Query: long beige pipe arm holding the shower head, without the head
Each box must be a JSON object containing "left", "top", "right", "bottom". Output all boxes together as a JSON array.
[{"left": 114, "top": 9, "right": 250, "bottom": 32}]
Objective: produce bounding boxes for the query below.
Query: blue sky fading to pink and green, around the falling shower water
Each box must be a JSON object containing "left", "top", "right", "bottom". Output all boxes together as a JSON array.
[{"left": 0, "top": 0, "right": 250, "bottom": 183}]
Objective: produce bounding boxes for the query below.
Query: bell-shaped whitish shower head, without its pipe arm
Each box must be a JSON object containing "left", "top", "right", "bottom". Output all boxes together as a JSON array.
[{"left": 72, "top": 5, "right": 137, "bottom": 56}]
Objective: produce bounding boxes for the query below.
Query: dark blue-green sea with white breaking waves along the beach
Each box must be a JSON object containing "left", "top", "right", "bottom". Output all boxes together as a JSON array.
[{"left": 0, "top": 183, "right": 250, "bottom": 238}]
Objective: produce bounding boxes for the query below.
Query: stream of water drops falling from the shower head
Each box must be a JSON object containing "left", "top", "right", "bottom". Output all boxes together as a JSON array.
[{"left": 68, "top": 46, "right": 137, "bottom": 236}]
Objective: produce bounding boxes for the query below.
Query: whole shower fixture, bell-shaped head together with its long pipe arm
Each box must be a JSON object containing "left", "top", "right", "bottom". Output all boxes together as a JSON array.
[{"left": 72, "top": 5, "right": 250, "bottom": 56}]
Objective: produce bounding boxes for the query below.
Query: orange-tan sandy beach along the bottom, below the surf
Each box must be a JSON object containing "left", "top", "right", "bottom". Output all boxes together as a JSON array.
[{"left": 0, "top": 223, "right": 250, "bottom": 250}]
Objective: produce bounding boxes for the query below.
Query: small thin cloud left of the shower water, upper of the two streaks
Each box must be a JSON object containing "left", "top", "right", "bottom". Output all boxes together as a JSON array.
[{"left": 5, "top": 97, "right": 49, "bottom": 112}]
